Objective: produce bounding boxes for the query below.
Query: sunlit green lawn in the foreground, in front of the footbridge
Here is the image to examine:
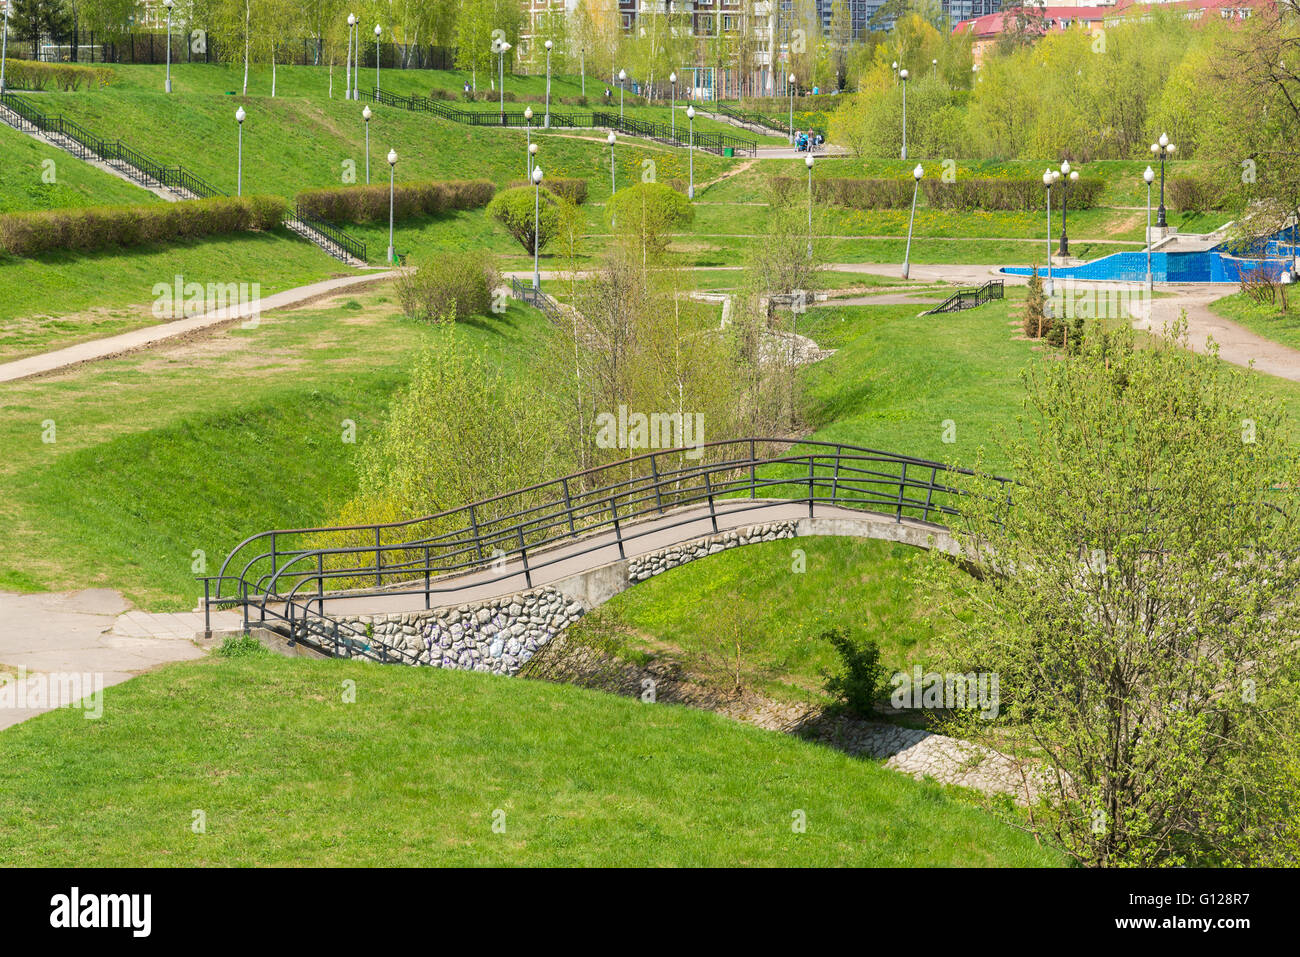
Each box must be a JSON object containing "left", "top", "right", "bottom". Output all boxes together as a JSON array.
[{"left": 0, "top": 655, "right": 1063, "bottom": 867}]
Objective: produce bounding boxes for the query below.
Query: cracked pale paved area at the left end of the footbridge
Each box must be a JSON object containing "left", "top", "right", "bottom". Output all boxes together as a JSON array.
[{"left": 0, "top": 588, "right": 239, "bottom": 728}]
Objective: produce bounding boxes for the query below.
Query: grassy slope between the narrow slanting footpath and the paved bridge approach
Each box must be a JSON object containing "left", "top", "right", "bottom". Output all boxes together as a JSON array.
[{"left": 0, "top": 289, "right": 541, "bottom": 609}]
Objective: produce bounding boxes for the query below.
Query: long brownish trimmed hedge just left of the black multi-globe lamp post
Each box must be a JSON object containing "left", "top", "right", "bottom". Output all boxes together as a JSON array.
[{"left": 768, "top": 177, "right": 1102, "bottom": 211}]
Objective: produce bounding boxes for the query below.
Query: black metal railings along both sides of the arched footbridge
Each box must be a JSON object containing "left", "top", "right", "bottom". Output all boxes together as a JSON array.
[{"left": 202, "top": 438, "right": 1009, "bottom": 661}]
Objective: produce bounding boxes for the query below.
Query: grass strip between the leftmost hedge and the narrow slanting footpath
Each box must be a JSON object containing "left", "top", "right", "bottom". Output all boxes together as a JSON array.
[{"left": 0, "top": 230, "right": 355, "bottom": 361}]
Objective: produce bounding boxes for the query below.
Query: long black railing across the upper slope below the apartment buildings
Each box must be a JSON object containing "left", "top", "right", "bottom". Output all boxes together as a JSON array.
[{"left": 361, "top": 87, "right": 758, "bottom": 156}]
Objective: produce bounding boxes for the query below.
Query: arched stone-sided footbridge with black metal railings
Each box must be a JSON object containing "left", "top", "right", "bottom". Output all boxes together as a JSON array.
[{"left": 202, "top": 438, "right": 1009, "bottom": 672}]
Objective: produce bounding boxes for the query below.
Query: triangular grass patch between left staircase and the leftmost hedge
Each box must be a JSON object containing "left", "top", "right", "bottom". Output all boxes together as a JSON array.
[{"left": 0, "top": 126, "right": 163, "bottom": 215}]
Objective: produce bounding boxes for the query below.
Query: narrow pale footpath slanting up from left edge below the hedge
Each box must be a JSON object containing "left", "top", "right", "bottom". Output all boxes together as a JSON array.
[{"left": 0, "top": 269, "right": 398, "bottom": 382}]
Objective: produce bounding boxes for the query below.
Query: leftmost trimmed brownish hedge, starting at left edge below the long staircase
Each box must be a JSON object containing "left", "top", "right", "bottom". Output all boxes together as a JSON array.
[{"left": 0, "top": 196, "right": 285, "bottom": 256}]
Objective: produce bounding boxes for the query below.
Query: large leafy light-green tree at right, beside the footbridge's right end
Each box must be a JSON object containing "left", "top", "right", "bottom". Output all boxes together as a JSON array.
[{"left": 927, "top": 322, "right": 1300, "bottom": 866}]
